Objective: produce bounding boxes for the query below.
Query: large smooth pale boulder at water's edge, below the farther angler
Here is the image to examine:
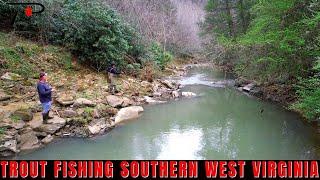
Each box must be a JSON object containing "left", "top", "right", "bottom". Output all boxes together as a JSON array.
[{"left": 115, "top": 106, "right": 144, "bottom": 124}]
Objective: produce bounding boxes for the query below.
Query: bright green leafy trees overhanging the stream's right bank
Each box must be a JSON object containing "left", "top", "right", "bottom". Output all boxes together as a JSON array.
[{"left": 202, "top": 0, "right": 320, "bottom": 119}]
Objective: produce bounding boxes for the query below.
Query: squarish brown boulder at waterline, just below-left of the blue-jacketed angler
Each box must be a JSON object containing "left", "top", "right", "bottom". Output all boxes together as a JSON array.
[{"left": 18, "top": 131, "right": 41, "bottom": 151}]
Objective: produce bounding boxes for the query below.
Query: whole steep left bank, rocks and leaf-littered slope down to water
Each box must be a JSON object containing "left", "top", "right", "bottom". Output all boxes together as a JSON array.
[{"left": 0, "top": 33, "right": 192, "bottom": 157}]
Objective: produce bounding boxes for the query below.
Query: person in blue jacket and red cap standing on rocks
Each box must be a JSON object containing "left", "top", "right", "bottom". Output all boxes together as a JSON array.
[{"left": 37, "top": 70, "right": 54, "bottom": 123}]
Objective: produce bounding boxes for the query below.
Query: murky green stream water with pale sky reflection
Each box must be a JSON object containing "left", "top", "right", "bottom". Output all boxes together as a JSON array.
[{"left": 16, "top": 68, "right": 320, "bottom": 160}]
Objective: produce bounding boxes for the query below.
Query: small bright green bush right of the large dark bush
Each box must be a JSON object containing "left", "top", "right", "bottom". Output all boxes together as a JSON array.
[{"left": 146, "top": 43, "right": 173, "bottom": 70}]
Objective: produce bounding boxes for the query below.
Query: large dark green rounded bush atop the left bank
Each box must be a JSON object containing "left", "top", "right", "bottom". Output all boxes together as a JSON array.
[{"left": 51, "top": 0, "right": 134, "bottom": 70}]
